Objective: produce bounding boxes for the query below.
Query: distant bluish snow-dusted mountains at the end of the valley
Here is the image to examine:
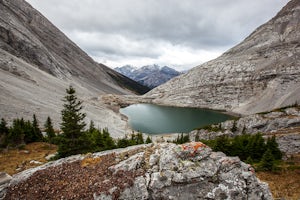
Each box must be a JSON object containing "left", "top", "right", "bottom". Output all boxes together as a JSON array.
[{"left": 115, "top": 65, "right": 181, "bottom": 88}]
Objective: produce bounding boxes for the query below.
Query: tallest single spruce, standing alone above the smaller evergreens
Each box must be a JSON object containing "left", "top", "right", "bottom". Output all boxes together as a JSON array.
[{"left": 58, "top": 86, "right": 88, "bottom": 157}]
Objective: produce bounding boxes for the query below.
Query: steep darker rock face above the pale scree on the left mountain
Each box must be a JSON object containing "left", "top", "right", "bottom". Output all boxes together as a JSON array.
[{"left": 0, "top": 0, "right": 125, "bottom": 93}]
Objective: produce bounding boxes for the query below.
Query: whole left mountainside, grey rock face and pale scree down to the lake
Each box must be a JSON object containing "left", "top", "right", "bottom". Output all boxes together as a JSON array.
[{"left": 0, "top": 0, "right": 146, "bottom": 136}]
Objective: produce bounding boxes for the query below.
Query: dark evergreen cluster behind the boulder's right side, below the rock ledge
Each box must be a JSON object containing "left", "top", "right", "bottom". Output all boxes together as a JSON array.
[{"left": 201, "top": 133, "right": 282, "bottom": 170}]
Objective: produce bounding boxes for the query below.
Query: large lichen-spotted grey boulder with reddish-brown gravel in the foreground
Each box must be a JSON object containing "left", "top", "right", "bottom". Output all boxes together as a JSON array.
[{"left": 0, "top": 142, "right": 272, "bottom": 200}]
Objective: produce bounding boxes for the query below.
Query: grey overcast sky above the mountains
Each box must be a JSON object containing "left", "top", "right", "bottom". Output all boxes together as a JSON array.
[{"left": 27, "top": 0, "right": 288, "bottom": 70}]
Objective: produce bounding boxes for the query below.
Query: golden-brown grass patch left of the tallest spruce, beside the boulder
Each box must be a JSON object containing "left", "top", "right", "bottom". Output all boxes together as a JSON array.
[{"left": 0, "top": 142, "right": 57, "bottom": 175}]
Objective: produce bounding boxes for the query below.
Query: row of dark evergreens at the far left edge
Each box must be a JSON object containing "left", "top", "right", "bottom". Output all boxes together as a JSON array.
[{"left": 0, "top": 115, "right": 44, "bottom": 148}]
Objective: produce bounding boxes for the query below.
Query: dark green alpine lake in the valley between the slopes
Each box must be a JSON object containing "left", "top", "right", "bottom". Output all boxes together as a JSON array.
[{"left": 120, "top": 104, "right": 232, "bottom": 134}]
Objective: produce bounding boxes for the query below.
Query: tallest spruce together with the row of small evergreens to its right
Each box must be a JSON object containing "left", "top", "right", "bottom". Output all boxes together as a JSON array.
[{"left": 56, "top": 86, "right": 152, "bottom": 157}]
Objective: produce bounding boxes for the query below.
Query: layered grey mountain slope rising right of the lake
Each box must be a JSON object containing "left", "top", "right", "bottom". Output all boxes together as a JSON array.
[{"left": 146, "top": 0, "right": 300, "bottom": 114}]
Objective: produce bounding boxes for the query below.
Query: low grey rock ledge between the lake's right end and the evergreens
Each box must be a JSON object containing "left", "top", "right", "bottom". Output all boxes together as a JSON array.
[{"left": 189, "top": 106, "right": 300, "bottom": 157}]
